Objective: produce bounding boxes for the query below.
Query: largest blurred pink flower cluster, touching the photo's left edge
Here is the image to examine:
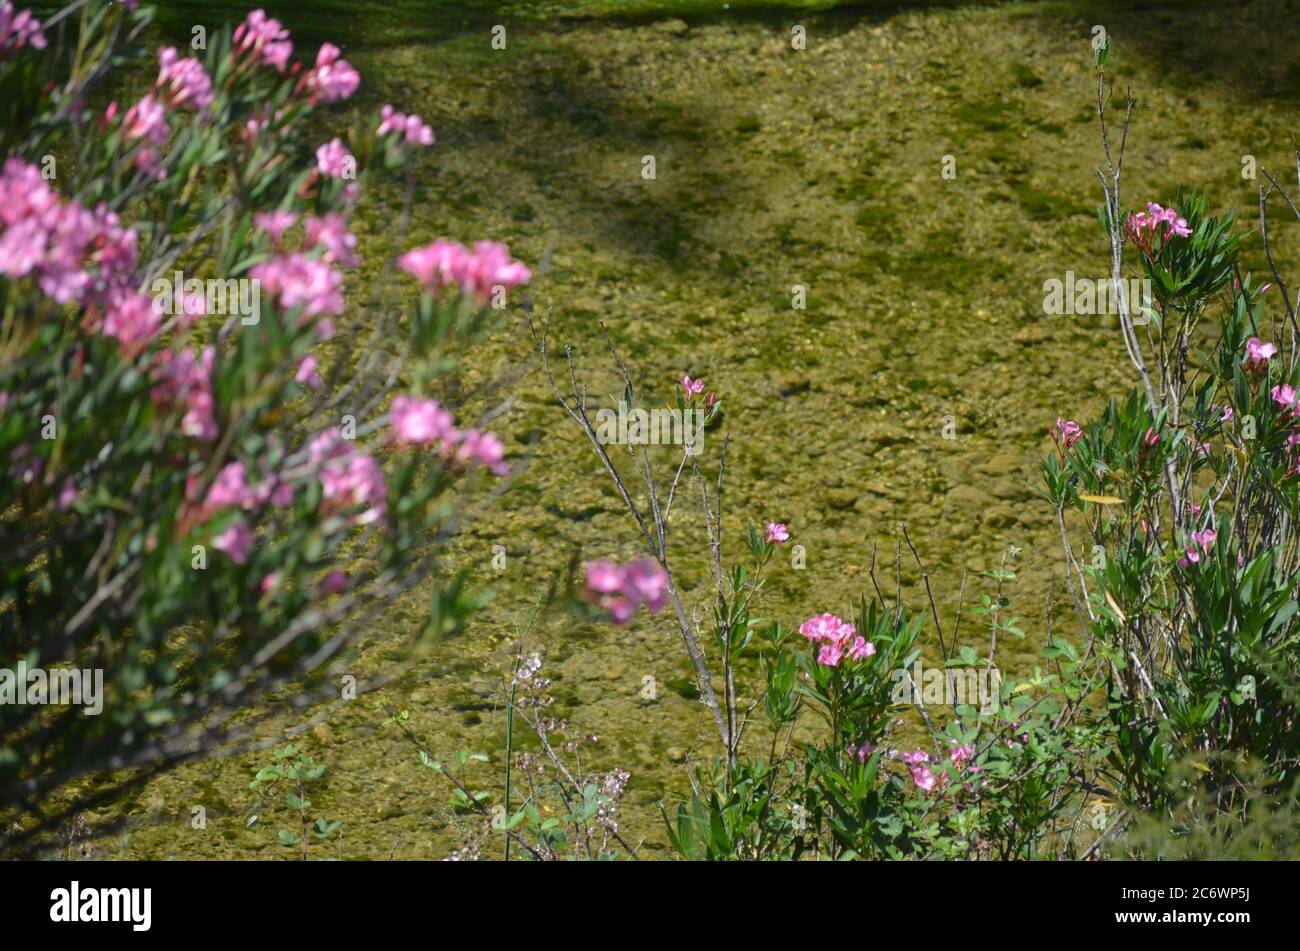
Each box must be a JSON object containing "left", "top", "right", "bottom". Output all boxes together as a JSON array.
[{"left": 0, "top": 159, "right": 160, "bottom": 346}]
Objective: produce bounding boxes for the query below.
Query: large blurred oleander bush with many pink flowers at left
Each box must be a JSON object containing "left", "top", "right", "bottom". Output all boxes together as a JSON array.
[{"left": 0, "top": 0, "right": 529, "bottom": 854}]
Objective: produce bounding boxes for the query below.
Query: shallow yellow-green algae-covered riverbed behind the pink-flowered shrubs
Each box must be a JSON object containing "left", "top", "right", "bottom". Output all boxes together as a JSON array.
[{"left": 73, "top": 0, "right": 1300, "bottom": 859}]
